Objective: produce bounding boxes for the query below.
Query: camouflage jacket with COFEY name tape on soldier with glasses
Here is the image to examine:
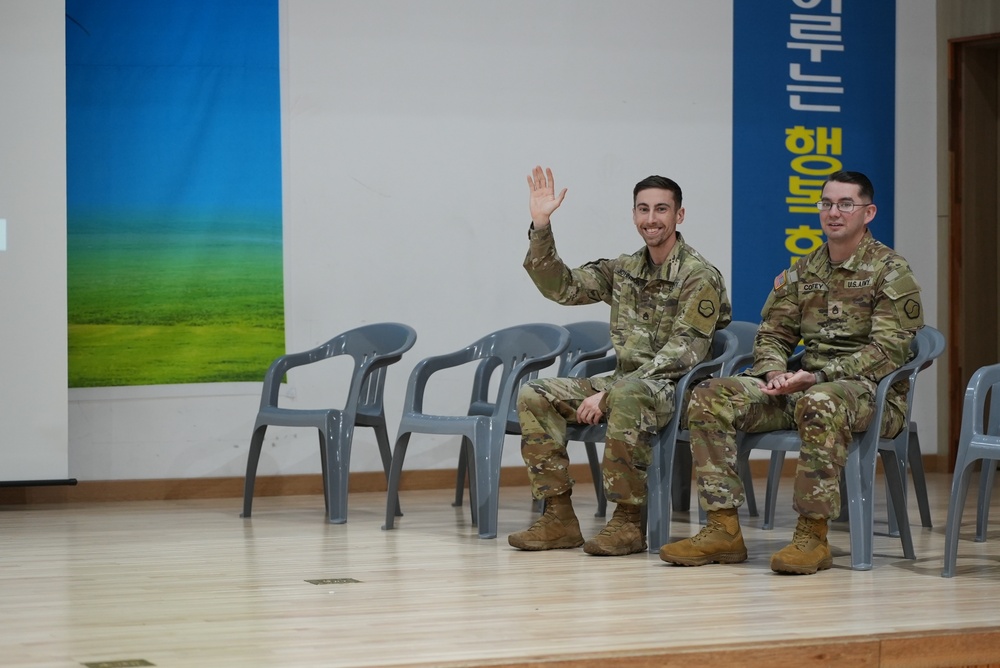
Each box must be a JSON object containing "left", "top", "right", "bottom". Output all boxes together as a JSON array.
[{"left": 748, "top": 230, "right": 924, "bottom": 405}]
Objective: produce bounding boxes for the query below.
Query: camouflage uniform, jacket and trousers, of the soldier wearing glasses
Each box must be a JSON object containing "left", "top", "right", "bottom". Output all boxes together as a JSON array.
[{"left": 688, "top": 230, "right": 923, "bottom": 519}]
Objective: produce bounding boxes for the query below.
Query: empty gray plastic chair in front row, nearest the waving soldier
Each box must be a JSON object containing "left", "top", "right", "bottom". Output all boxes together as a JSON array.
[{"left": 382, "top": 323, "right": 569, "bottom": 538}]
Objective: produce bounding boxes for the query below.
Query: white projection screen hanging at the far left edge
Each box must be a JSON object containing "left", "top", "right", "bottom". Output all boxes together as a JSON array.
[{"left": 0, "top": 0, "right": 69, "bottom": 481}]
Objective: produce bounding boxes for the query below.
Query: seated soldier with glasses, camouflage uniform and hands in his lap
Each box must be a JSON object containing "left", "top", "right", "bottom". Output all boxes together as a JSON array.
[{"left": 660, "top": 172, "right": 923, "bottom": 574}]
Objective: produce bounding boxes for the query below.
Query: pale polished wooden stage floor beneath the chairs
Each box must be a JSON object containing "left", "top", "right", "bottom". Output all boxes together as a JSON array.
[{"left": 0, "top": 474, "right": 1000, "bottom": 668}]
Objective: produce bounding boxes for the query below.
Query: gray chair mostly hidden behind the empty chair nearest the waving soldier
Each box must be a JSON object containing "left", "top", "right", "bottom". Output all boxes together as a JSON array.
[{"left": 452, "top": 320, "right": 611, "bottom": 522}]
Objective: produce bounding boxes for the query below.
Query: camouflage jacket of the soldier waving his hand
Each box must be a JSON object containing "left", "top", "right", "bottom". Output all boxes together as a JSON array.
[{"left": 524, "top": 225, "right": 732, "bottom": 382}]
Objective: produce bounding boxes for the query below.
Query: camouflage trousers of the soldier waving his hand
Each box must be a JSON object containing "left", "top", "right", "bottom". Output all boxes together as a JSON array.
[{"left": 517, "top": 377, "right": 674, "bottom": 505}]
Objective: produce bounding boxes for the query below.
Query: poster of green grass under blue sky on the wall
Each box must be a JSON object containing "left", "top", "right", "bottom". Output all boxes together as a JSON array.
[{"left": 66, "top": 0, "right": 284, "bottom": 387}]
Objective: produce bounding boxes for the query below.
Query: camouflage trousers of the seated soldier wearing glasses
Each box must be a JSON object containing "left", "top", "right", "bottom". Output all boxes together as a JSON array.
[{"left": 688, "top": 376, "right": 904, "bottom": 519}]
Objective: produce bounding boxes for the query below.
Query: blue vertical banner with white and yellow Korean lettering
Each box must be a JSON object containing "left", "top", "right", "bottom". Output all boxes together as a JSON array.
[{"left": 732, "top": 0, "right": 896, "bottom": 322}]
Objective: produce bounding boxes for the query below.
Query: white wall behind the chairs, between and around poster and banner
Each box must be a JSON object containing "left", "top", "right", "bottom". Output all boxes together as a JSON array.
[{"left": 60, "top": 0, "right": 938, "bottom": 480}]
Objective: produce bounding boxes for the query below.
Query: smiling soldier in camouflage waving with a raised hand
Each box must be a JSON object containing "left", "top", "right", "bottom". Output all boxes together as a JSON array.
[{"left": 508, "top": 167, "right": 732, "bottom": 555}]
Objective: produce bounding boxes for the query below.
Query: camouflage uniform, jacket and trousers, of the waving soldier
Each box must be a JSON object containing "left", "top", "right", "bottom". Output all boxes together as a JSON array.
[{"left": 517, "top": 226, "right": 732, "bottom": 505}]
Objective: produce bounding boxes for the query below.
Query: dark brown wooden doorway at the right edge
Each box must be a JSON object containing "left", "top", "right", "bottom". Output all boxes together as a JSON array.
[{"left": 947, "top": 34, "right": 1000, "bottom": 471}]
